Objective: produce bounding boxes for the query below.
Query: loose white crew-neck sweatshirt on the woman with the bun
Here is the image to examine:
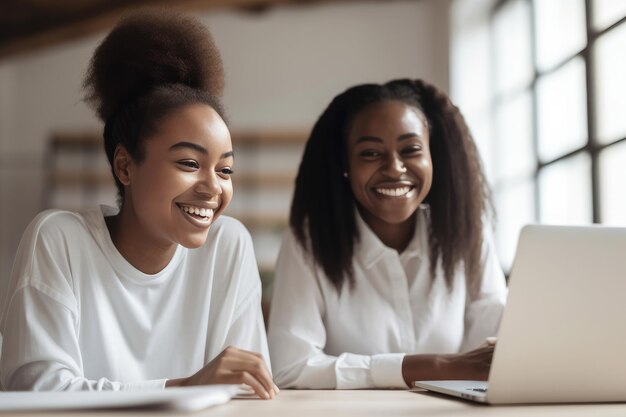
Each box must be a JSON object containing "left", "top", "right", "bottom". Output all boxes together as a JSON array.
[{"left": 0, "top": 207, "right": 269, "bottom": 390}]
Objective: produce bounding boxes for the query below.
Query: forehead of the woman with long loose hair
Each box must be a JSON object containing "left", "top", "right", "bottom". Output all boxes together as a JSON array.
[{"left": 348, "top": 100, "right": 426, "bottom": 139}]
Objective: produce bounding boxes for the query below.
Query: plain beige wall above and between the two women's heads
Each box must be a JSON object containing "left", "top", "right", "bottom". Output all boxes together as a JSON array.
[{"left": 207, "top": 0, "right": 448, "bottom": 128}]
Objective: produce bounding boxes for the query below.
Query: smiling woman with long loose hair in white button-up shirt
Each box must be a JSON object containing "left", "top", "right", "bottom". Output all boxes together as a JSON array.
[{"left": 268, "top": 80, "right": 506, "bottom": 389}]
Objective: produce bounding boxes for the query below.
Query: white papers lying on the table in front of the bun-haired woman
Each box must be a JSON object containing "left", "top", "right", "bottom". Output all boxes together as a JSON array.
[{"left": 0, "top": 385, "right": 240, "bottom": 412}]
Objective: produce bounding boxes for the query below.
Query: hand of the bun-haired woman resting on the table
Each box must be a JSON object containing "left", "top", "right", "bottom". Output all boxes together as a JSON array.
[{"left": 165, "top": 346, "right": 279, "bottom": 400}]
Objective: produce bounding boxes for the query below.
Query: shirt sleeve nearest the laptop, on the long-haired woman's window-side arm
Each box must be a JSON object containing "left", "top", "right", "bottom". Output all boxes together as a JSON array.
[{"left": 461, "top": 228, "right": 508, "bottom": 352}]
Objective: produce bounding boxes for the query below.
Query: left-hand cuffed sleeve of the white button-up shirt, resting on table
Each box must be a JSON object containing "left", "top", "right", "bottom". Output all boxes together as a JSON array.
[{"left": 268, "top": 233, "right": 406, "bottom": 389}]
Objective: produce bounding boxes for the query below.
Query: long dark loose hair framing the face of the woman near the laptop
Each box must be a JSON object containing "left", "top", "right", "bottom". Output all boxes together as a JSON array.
[{"left": 289, "top": 79, "right": 494, "bottom": 291}]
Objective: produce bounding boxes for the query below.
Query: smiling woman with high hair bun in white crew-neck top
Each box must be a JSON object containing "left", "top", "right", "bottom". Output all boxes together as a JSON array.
[{"left": 0, "top": 11, "right": 278, "bottom": 399}]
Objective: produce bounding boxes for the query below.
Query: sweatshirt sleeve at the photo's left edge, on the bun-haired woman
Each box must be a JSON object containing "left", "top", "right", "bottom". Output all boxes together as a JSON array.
[{"left": 0, "top": 212, "right": 165, "bottom": 391}]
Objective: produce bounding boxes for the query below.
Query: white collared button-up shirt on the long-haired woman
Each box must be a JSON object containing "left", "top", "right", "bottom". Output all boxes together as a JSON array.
[{"left": 268, "top": 206, "right": 507, "bottom": 389}]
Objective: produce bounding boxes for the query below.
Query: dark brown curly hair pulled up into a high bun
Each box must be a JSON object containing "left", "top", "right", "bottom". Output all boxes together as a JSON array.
[{"left": 83, "top": 9, "right": 225, "bottom": 203}]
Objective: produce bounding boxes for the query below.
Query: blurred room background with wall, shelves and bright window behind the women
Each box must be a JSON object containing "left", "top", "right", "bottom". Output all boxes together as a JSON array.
[{"left": 0, "top": 0, "right": 626, "bottom": 306}]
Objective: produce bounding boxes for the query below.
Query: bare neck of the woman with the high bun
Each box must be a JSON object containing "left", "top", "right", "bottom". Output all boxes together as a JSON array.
[{"left": 105, "top": 202, "right": 177, "bottom": 275}]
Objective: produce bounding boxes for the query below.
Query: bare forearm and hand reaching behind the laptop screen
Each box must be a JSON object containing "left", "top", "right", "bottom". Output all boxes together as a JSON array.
[{"left": 402, "top": 337, "right": 496, "bottom": 386}]
